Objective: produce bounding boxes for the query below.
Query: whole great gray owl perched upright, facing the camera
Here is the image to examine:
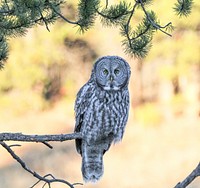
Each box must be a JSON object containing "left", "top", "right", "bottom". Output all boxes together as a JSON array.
[{"left": 75, "top": 56, "right": 131, "bottom": 182}]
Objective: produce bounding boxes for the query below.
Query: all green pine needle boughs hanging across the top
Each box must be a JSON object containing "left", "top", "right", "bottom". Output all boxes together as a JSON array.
[{"left": 0, "top": 0, "right": 193, "bottom": 67}]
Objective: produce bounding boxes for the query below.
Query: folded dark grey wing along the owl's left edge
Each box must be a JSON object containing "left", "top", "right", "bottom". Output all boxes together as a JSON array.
[{"left": 74, "top": 83, "right": 92, "bottom": 154}]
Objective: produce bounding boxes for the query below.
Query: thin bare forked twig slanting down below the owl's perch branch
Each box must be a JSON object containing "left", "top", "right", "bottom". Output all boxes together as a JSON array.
[{"left": 0, "top": 141, "right": 83, "bottom": 188}]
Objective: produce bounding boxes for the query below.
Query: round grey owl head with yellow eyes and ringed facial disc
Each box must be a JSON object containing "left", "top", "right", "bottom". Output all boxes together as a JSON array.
[{"left": 91, "top": 56, "right": 131, "bottom": 91}]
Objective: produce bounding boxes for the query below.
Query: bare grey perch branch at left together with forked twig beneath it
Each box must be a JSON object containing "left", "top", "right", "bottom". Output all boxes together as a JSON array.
[{"left": 0, "top": 133, "right": 82, "bottom": 188}]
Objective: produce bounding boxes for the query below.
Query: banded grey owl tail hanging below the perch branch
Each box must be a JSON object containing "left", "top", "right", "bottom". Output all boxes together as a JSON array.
[{"left": 81, "top": 141, "right": 104, "bottom": 182}]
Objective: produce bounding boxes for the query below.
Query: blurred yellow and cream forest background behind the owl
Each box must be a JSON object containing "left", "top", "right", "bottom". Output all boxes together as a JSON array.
[{"left": 0, "top": 0, "right": 200, "bottom": 188}]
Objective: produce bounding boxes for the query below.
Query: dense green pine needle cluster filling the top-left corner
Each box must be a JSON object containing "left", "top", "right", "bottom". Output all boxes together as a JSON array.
[{"left": 0, "top": 0, "right": 63, "bottom": 67}]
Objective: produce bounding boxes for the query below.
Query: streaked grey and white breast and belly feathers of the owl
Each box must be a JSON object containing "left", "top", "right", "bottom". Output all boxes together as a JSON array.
[{"left": 81, "top": 92, "right": 128, "bottom": 140}]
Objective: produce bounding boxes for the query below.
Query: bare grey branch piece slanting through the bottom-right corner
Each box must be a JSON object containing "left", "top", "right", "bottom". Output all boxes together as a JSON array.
[{"left": 174, "top": 163, "right": 200, "bottom": 188}]
